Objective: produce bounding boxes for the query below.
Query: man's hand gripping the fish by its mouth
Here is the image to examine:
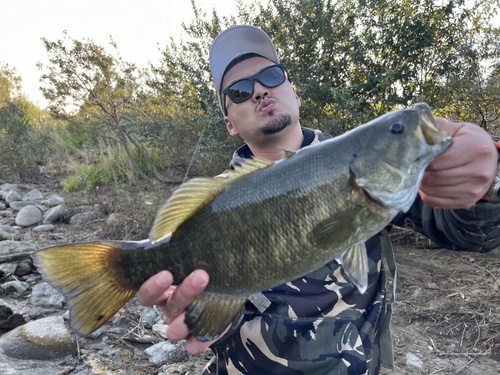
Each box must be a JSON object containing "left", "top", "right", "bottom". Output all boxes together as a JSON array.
[{"left": 420, "top": 118, "right": 498, "bottom": 209}]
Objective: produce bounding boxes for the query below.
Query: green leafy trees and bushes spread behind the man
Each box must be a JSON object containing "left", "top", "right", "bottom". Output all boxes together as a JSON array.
[{"left": 10, "top": 0, "right": 500, "bottom": 188}]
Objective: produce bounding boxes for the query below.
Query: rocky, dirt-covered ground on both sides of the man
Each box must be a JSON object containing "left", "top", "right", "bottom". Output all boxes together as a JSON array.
[{"left": 0, "top": 178, "right": 500, "bottom": 375}]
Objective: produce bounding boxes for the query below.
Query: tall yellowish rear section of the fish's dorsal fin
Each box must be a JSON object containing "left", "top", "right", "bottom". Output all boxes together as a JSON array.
[{"left": 149, "top": 177, "right": 229, "bottom": 243}]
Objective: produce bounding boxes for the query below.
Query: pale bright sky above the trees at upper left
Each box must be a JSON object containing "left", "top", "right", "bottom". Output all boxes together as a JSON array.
[{"left": 0, "top": 0, "right": 242, "bottom": 107}]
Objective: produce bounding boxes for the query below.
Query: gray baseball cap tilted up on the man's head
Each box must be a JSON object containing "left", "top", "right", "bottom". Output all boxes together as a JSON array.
[{"left": 210, "top": 25, "right": 279, "bottom": 115}]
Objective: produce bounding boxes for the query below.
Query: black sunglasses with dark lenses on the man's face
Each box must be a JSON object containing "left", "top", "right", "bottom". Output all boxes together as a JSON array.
[{"left": 222, "top": 64, "right": 286, "bottom": 114}]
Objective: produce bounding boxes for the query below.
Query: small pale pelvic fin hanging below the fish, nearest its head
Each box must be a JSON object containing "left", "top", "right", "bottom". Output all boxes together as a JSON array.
[{"left": 337, "top": 242, "right": 368, "bottom": 294}]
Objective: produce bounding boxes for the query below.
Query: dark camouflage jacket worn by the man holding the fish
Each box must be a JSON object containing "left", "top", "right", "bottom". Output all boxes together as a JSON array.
[{"left": 203, "top": 128, "right": 500, "bottom": 375}]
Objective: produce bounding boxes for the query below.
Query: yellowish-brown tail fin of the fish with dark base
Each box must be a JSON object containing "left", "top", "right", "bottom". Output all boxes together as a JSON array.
[{"left": 32, "top": 242, "right": 137, "bottom": 336}]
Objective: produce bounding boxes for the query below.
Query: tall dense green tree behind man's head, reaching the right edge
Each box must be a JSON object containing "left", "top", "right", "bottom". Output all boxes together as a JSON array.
[{"left": 150, "top": 0, "right": 500, "bottom": 140}]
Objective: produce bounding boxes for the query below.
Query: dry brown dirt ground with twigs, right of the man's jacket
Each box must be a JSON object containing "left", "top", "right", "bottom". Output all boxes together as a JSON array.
[{"left": 384, "top": 235, "right": 500, "bottom": 375}]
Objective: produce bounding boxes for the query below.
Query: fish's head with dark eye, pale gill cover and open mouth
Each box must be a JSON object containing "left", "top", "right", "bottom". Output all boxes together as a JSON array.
[{"left": 350, "top": 103, "right": 452, "bottom": 212}]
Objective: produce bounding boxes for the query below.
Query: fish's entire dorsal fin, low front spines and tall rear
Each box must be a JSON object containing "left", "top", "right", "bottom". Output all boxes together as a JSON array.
[{"left": 149, "top": 158, "right": 273, "bottom": 243}]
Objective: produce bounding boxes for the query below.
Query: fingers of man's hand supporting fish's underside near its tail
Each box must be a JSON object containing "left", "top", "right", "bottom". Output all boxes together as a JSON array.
[{"left": 137, "top": 270, "right": 215, "bottom": 354}]
